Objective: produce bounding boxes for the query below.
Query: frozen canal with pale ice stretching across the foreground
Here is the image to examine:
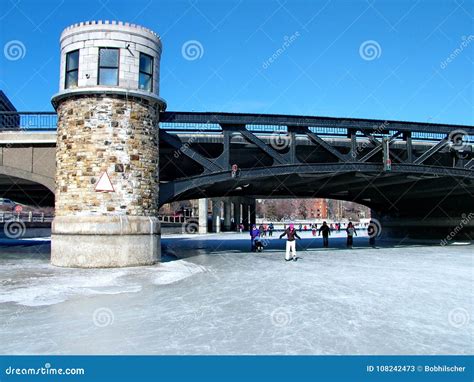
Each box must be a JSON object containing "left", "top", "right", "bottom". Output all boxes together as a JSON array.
[{"left": 0, "top": 233, "right": 474, "bottom": 354}]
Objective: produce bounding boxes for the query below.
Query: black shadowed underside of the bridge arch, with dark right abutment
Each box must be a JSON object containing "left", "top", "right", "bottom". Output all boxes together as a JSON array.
[{"left": 162, "top": 166, "right": 474, "bottom": 240}]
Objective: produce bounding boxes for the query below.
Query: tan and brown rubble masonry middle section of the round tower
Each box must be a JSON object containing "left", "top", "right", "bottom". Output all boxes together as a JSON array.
[{"left": 56, "top": 95, "right": 159, "bottom": 216}]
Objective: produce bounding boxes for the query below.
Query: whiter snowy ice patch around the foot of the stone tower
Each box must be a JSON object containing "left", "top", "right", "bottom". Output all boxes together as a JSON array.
[{"left": 0, "top": 257, "right": 205, "bottom": 306}]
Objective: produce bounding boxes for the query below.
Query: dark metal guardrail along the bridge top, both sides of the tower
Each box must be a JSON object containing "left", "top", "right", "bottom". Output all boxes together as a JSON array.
[{"left": 0, "top": 111, "right": 474, "bottom": 142}]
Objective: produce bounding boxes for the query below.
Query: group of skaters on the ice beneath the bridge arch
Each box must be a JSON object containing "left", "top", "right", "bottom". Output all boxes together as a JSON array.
[{"left": 250, "top": 222, "right": 368, "bottom": 261}]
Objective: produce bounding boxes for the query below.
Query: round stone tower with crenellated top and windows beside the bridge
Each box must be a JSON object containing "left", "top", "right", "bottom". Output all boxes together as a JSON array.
[{"left": 51, "top": 21, "right": 166, "bottom": 267}]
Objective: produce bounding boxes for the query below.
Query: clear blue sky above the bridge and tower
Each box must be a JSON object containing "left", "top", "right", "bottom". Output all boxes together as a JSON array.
[{"left": 0, "top": 0, "right": 474, "bottom": 124}]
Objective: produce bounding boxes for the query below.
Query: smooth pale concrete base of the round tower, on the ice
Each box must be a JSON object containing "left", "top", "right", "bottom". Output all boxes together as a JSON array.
[{"left": 51, "top": 216, "right": 161, "bottom": 268}]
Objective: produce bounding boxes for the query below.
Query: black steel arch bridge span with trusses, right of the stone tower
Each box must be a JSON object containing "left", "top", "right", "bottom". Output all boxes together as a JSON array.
[{"left": 160, "top": 112, "right": 474, "bottom": 201}]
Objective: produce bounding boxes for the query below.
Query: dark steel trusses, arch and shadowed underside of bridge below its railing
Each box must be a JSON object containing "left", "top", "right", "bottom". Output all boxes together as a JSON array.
[{"left": 160, "top": 113, "right": 474, "bottom": 239}]
